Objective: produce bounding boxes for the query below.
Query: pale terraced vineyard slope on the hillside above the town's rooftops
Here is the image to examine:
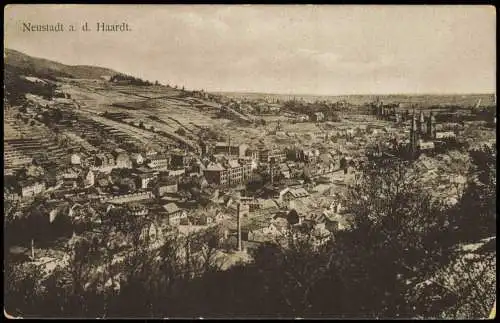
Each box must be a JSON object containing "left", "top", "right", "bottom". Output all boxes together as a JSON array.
[{"left": 55, "top": 81, "right": 235, "bottom": 151}]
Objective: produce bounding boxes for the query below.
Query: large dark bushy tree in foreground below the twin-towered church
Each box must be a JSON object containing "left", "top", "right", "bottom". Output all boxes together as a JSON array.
[{"left": 339, "top": 163, "right": 452, "bottom": 317}]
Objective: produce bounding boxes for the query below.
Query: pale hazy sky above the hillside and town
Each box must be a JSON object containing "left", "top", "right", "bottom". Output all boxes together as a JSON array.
[{"left": 4, "top": 5, "right": 496, "bottom": 95}]
